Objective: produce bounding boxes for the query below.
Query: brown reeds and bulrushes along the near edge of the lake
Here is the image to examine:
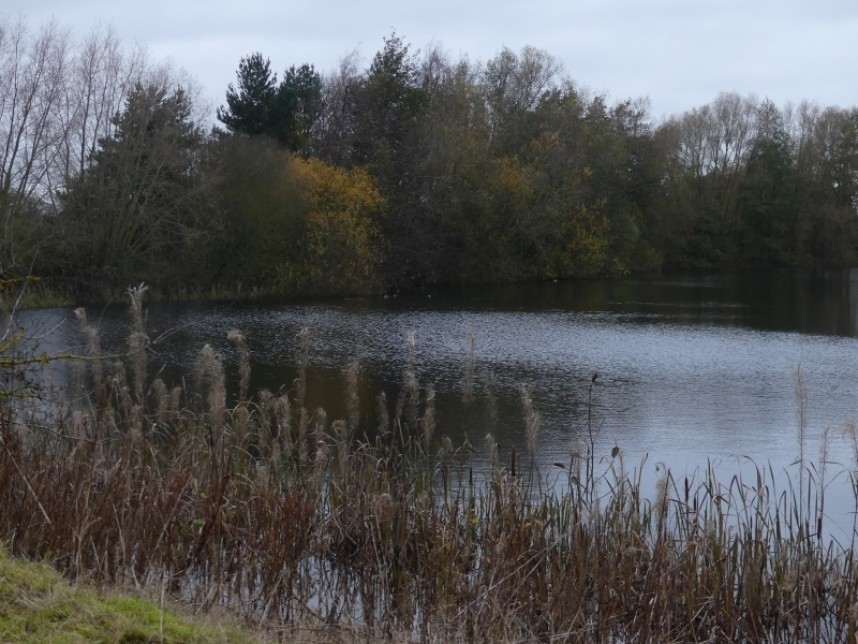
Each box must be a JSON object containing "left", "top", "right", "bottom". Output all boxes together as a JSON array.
[{"left": 0, "top": 289, "right": 858, "bottom": 642}]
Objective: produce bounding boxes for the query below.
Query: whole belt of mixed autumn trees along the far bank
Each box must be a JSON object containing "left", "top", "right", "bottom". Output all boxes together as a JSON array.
[{"left": 0, "top": 21, "right": 858, "bottom": 297}]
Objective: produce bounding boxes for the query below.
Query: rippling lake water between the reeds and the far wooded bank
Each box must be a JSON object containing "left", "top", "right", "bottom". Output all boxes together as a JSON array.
[{"left": 18, "top": 270, "right": 858, "bottom": 540}]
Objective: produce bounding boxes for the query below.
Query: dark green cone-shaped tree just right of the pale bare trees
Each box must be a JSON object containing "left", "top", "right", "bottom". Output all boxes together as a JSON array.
[{"left": 57, "top": 85, "right": 209, "bottom": 292}]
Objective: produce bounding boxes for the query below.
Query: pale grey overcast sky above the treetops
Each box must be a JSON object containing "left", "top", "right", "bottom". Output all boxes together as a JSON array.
[{"left": 0, "top": 0, "right": 858, "bottom": 119}]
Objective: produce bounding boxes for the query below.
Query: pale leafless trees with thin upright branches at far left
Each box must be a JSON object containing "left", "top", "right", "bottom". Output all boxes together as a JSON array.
[{"left": 0, "top": 18, "right": 162, "bottom": 273}]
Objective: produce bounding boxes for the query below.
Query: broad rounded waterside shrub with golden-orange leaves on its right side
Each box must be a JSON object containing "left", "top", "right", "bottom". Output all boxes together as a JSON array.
[{"left": 210, "top": 137, "right": 383, "bottom": 294}]
